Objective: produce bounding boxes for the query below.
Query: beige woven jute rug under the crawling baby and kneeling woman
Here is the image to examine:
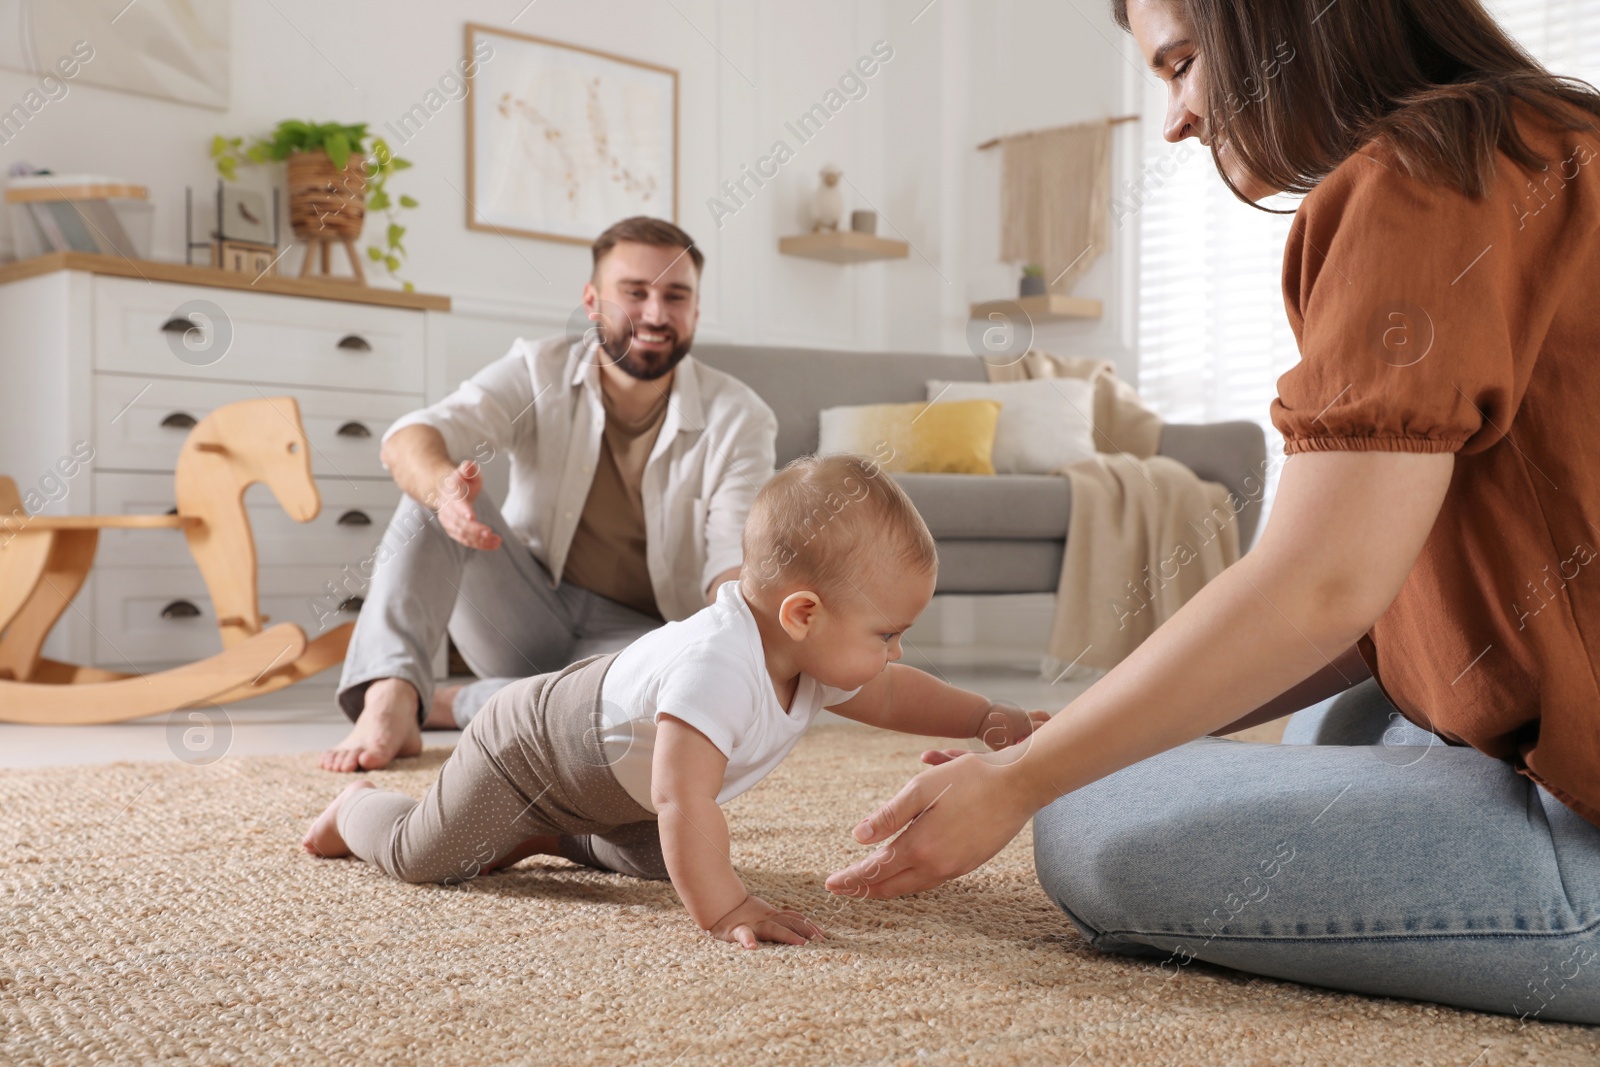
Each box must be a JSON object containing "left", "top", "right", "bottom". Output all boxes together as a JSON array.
[{"left": 0, "top": 726, "right": 1600, "bottom": 1067}]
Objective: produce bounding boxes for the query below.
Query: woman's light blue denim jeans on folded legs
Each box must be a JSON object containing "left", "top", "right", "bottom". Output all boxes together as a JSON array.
[{"left": 1034, "top": 680, "right": 1600, "bottom": 1024}]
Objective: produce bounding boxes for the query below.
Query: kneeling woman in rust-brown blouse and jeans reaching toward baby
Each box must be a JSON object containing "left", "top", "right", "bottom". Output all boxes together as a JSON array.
[{"left": 829, "top": 0, "right": 1600, "bottom": 1022}]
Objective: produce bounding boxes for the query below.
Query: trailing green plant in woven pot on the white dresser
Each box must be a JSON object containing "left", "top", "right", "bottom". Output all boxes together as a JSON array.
[{"left": 211, "top": 118, "right": 416, "bottom": 290}]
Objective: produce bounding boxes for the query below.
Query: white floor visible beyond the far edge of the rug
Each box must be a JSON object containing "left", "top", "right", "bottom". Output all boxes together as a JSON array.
[{"left": 0, "top": 648, "right": 1088, "bottom": 768}]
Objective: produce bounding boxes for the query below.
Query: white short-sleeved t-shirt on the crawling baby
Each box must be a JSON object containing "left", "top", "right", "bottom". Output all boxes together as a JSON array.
[{"left": 600, "top": 581, "right": 861, "bottom": 811}]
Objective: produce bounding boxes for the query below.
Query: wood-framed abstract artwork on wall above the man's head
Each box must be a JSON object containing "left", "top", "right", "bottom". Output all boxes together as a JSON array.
[{"left": 467, "top": 22, "right": 678, "bottom": 245}]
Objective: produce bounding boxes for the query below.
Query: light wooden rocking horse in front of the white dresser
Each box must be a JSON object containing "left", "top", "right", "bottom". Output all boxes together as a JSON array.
[{"left": 0, "top": 397, "right": 355, "bottom": 723}]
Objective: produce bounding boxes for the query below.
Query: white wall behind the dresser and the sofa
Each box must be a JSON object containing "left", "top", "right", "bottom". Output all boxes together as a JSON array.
[{"left": 0, "top": 0, "right": 1136, "bottom": 390}]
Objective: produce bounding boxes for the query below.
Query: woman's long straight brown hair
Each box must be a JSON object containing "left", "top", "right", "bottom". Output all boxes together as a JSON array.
[{"left": 1112, "top": 0, "right": 1600, "bottom": 200}]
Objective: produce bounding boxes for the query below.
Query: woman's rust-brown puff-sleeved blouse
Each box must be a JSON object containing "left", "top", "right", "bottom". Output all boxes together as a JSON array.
[{"left": 1272, "top": 97, "right": 1600, "bottom": 824}]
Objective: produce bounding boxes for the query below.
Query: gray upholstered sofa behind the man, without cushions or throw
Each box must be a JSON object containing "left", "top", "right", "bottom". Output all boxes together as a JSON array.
[{"left": 694, "top": 344, "right": 1267, "bottom": 593}]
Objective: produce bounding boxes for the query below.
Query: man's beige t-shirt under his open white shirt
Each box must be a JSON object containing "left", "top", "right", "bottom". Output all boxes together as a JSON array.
[{"left": 562, "top": 389, "right": 672, "bottom": 619}]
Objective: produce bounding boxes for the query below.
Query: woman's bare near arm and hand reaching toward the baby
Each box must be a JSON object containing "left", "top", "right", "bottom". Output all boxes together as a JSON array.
[{"left": 827, "top": 451, "right": 1454, "bottom": 897}]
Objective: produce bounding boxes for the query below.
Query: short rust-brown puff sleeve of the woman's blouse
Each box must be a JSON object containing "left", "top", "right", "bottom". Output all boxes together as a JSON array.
[{"left": 1272, "top": 149, "right": 1538, "bottom": 453}]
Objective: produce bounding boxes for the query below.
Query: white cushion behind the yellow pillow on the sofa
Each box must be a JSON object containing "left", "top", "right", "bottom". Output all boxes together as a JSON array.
[{"left": 928, "top": 378, "right": 1094, "bottom": 474}]
